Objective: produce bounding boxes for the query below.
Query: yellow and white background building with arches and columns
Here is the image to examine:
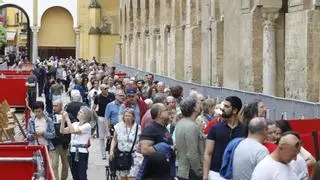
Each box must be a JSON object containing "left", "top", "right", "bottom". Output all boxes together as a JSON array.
[{"left": 0, "top": 0, "right": 119, "bottom": 63}]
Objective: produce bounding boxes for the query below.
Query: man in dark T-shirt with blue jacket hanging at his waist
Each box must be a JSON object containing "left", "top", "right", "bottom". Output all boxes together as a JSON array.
[{"left": 136, "top": 103, "right": 175, "bottom": 180}]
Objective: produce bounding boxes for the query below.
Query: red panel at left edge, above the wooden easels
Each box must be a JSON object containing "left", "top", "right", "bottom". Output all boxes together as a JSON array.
[{"left": 0, "top": 70, "right": 30, "bottom": 107}]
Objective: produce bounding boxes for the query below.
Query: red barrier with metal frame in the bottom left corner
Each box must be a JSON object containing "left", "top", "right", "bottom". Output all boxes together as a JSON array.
[{"left": 0, "top": 142, "right": 55, "bottom": 180}]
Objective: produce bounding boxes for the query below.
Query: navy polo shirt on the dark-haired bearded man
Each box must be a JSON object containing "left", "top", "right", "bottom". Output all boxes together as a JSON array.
[{"left": 207, "top": 120, "right": 245, "bottom": 172}]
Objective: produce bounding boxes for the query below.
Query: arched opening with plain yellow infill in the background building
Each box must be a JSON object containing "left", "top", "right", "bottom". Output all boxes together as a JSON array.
[{"left": 38, "top": 6, "right": 76, "bottom": 59}]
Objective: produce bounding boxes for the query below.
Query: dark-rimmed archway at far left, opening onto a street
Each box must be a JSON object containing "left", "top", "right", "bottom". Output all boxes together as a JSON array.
[{"left": 0, "top": 4, "right": 32, "bottom": 62}]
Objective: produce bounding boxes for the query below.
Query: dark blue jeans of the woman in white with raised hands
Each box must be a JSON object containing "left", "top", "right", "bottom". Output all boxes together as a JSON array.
[{"left": 69, "top": 152, "right": 89, "bottom": 180}]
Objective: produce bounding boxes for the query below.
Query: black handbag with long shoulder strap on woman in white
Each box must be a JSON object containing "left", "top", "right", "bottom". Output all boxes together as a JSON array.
[{"left": 110, "top": 123, "right": 139, "bottom": 171}]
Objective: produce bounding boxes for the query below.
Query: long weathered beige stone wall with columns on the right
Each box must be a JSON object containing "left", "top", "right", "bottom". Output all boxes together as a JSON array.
[{"left": 120, "top": 0, "right": 320, "bottom": 102}]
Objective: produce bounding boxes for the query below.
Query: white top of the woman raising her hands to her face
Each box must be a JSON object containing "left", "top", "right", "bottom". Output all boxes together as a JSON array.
[{"left": 70, "top": 122, "right": 91, "bottom": 153}]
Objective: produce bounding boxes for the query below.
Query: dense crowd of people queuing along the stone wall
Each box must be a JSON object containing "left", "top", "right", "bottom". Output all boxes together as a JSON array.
[{"left": 26, "top": 57, "right": 316, "bottom": 180}]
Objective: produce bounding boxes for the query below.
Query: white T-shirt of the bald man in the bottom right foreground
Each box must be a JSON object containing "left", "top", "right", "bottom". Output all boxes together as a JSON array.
[{"left": 252, "top": 155, "right": 299, "bottom": 180}]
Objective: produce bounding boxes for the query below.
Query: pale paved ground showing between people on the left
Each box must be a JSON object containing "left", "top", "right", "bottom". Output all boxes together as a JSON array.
[{"left": 11, "top": 95, "right": 107, "bottom": 180}]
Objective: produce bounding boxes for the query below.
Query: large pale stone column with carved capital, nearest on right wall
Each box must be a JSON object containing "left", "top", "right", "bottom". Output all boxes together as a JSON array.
[{"left": 263, "top": 11, "right": 279, "bottom": 95}]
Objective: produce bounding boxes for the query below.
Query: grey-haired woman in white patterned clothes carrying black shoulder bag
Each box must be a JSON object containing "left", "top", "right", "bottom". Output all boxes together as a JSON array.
[{"left": 109, "top": 108, "right": 142, "bottom": 180}]
